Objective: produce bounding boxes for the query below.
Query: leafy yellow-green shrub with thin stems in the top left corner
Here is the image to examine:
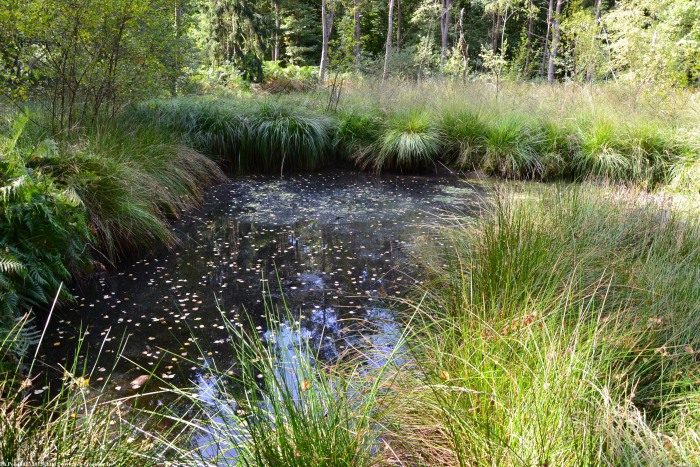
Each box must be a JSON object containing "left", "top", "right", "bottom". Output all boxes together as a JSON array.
[{"left": 2, "top": 0, "right": 191, "bottom": 130}]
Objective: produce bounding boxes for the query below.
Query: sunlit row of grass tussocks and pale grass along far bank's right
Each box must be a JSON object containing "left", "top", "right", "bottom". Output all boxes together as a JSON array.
[{"left": 330, "top": 82, "right": 698, "bottom": 183}]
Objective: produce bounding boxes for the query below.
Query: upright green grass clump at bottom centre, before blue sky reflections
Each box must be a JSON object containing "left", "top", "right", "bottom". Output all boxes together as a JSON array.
[{"left": 172, "top": 308, "right": 400, "bottom": 466}]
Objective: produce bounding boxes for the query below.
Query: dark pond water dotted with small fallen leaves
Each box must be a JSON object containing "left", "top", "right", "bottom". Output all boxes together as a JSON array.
[{"left": 40, "top": 171, "right": 486, "bottom": 395}]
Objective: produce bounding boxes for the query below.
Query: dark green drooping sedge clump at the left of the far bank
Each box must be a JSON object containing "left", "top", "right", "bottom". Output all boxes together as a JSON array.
[{"left": 132, "top": 99, "right": 335, "bottom": 174}]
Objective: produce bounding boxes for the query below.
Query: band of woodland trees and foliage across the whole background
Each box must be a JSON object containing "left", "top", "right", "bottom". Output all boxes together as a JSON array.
[{"left": 0, "top": 0, "right": 700, "bottom": 127}]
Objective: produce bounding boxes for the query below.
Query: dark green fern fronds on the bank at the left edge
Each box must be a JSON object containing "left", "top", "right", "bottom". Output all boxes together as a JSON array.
[{"left": 0, "top": 118, "right": 91, "bottom": 346}]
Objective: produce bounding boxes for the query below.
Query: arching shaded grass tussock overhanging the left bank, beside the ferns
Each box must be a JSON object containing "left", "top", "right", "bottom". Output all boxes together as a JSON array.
[{"left": 21, "top": 120, "right": 224, "bottom": 261}]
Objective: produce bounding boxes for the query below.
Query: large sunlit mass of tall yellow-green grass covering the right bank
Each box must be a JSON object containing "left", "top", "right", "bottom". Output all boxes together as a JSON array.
[{"left": 386, "top": 186, "right": 700, "bottom": 465}]
